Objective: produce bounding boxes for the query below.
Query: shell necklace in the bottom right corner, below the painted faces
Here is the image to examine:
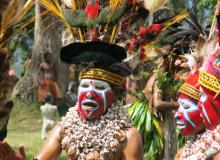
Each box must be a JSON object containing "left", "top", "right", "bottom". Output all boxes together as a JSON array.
[{"left": 181, "top": 125, "right": 220, "bottom": 160}]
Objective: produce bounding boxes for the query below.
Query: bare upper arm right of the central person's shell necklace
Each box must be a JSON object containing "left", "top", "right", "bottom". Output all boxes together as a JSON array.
[{"left": 123, "top": 128, "right": 144, "bottom": 160}]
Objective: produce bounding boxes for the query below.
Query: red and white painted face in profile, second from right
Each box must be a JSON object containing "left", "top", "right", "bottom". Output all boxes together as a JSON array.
[{"left": 175, "top": 95, "right": 204, "bottom": 136}]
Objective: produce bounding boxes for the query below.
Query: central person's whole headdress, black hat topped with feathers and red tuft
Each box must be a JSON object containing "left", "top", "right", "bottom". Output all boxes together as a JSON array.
[{"left": 40, "top": 0, "right": 144, "bottom": 80}]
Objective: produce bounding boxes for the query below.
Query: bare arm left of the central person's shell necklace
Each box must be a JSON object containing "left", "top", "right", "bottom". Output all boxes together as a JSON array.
[{"left": 35, "top": 126, "right": 62, "bottom": 160}]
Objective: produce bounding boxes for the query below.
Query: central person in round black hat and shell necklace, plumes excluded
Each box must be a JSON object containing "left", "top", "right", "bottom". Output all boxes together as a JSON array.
[{"left": 36, "top": 41, "right": 143, "bottom": 160}]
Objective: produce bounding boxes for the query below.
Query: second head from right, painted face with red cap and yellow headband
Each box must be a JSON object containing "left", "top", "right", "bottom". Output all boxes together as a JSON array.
[{"left": 175, "top": 70, "right": 205, "bottom": 136}]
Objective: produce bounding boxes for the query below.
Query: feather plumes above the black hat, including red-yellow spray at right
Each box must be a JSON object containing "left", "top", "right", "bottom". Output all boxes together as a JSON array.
[{"left": 40, "top": 0, "right": 188, "bottom": 71}]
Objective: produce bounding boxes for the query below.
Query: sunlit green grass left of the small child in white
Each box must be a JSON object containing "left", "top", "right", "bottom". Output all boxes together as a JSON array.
[{"left": 5, "top": 101, "right": 67, "bottom": 160}]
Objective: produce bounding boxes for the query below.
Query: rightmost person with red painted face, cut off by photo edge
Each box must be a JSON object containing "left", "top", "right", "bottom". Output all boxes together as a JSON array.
[{"left": 175, "top": 30, "right": 220, "bottom": 160}]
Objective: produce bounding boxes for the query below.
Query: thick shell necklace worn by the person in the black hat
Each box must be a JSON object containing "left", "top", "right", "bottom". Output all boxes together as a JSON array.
[{"left": 60, "top": 104, "right": 132, "bottom": 160}]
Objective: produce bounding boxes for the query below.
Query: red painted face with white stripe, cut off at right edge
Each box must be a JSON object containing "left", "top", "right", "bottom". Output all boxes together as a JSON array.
[{"left": 198, "top": 87, "right": 220, "bottom": 129}]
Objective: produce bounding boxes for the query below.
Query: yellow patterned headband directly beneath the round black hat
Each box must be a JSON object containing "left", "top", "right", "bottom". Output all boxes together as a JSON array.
[{"left": 80, "top": 68, "right": 125, "bottom": 86}]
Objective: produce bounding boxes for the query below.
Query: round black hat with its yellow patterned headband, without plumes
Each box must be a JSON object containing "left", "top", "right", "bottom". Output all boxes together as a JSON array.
[{"left": 60, "top": 41, "right": 131, "bottom": 87}]
